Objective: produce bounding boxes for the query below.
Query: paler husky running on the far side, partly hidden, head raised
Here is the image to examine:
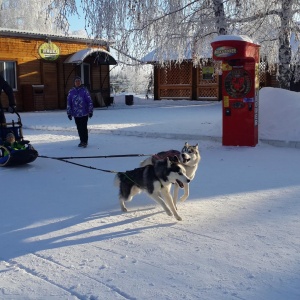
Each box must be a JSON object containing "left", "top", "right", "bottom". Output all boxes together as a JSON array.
[{"left": 140, "top": 142, "right": 201, "bottom": 207}]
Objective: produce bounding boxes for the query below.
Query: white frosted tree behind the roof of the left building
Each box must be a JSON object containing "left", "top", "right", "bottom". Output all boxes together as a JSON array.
[{"left": 0, "top": 0, "right": 67, "bottom": 33}]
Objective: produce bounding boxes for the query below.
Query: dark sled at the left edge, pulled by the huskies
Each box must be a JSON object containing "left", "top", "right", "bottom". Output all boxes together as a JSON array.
[{"left": 0, "top": 111, "right": 38, "bottom": 167}]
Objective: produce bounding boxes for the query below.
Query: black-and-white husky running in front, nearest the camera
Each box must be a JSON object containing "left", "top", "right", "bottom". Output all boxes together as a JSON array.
[{"left": 115, "top": 157, "right": 190, "bottom": 221}]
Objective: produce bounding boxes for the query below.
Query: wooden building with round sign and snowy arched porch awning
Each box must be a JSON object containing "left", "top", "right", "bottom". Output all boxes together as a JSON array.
[{"left": 0, "top": 29, "right": 117, "bottom": 111}]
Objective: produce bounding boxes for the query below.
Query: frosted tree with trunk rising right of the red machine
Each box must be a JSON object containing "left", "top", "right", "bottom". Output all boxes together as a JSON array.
[{"left": 231, "top": 0, "right": 300, "bottom": 89}]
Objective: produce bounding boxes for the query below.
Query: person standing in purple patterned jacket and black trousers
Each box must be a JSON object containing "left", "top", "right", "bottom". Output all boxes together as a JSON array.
[{"left": 67, "top": 76, "right": 93, "bottom": 148}]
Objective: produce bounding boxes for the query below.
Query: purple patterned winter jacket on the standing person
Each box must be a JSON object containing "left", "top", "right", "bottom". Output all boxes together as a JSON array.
[{"left": 67, "top": 85, "right": 93, "bottom": 117}]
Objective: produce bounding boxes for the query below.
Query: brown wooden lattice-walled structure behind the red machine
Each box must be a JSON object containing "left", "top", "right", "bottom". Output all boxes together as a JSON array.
[{"left": 142, "top": 50, "right": 300, "bottom": 101}]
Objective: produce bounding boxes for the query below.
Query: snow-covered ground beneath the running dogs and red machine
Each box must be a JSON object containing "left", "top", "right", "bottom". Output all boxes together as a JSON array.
[{"left": 0, "top": 88, "right": 300, "bottom": 300}]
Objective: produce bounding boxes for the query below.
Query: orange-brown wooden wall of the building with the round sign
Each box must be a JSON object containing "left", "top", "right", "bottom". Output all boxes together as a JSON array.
[{"left": 0, "top": 31, "right": 109, "bottom": 111}]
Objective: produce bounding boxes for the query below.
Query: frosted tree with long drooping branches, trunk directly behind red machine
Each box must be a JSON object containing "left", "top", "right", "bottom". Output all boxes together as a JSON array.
[{"left": 52, "top": 0, "right": 235, "bottom": 62}]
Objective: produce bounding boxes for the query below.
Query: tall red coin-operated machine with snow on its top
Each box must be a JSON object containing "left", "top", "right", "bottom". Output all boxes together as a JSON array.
[{"left": 211, "top": 35, "right": 260, "bottom": 147}]
